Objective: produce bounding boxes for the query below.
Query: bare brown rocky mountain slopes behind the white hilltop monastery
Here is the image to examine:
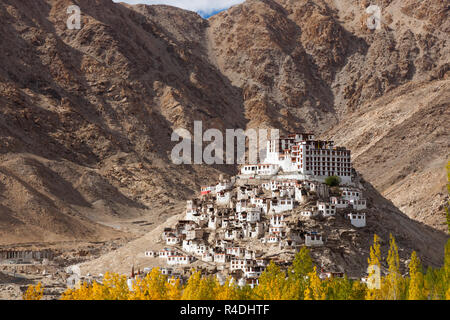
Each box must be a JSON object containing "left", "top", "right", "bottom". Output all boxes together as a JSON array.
[{"left": 0, "top": 0, "right": 450, "bottom": 249}]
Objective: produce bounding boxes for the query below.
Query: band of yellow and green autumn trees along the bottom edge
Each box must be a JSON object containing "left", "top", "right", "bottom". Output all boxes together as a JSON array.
[{"left": 27, "top": 235, "right": 450, "bottom": 300}]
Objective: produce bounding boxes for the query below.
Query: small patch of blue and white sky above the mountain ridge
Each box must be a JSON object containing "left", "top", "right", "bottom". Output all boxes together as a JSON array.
[{"left": 113, "top": 0, "right": 245, "bottom": 18}]
